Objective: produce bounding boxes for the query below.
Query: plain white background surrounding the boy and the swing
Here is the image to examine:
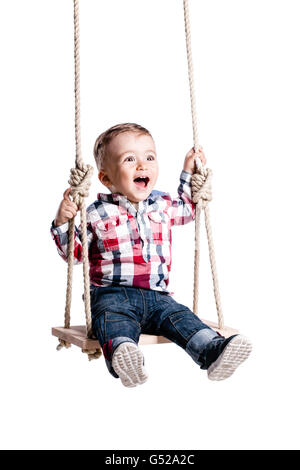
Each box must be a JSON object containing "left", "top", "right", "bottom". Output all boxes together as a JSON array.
[{"left": 0, "top": 0, "right": 300, "bottom": 450}]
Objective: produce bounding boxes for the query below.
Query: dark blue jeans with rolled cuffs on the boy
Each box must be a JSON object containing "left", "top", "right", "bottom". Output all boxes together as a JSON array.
[{"left": 91, "top": 286, "right": 218, "bottom": 377}]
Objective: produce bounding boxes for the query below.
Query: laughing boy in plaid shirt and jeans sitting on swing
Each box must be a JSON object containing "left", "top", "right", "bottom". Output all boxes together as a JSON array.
[{"left": 51, "top": 123, "right": 251, "bottom": 387}]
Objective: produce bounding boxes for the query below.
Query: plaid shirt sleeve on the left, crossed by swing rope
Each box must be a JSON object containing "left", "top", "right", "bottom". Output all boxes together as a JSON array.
[{"left": 50, "top": 221, "right": 93, "bottom": 264}]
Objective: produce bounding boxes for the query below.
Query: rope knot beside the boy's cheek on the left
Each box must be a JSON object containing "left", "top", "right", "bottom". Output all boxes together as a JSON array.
[{"left": 69, "top": 164, "right": 93, "bottom": 208}]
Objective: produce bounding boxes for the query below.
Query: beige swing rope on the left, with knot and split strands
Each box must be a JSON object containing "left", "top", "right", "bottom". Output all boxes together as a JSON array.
[{"left": 58, "top": 0, "right": 93, "bottom": 349}]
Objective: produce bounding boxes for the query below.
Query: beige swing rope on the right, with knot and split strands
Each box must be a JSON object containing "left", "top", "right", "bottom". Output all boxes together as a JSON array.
[{"left": 183, "top": 0, "right": 224, "bottom": 329}]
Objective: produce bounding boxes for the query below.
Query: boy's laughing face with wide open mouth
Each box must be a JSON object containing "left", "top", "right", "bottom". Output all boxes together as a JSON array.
[{"left": 99, "top": 132, "right": 158, "bottom": 202}]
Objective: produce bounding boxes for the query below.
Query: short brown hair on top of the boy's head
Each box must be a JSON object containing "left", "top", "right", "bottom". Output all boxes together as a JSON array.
[{"left": 94, "top": 122, "right": 152, "bottom": 171}]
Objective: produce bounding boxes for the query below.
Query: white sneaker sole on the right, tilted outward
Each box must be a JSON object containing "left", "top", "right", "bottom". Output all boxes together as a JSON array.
[{"left": 207, "top": 335, "right": 252, "bottom": 380}]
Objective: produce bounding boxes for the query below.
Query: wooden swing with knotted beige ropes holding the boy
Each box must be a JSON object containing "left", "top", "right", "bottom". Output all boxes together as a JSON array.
[{"left": 52, "top": 0, "right": 238, "bottom": 360}]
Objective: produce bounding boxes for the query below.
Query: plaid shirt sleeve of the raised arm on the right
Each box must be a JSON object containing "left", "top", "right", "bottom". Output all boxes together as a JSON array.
[{"left": 168, "top": 170, "right": 196, "bottom": 225}]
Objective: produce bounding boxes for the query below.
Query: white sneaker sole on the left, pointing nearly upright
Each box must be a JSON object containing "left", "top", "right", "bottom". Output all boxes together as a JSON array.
[{"left": 112, "top": 342, "right": 148, "bottom": 387}]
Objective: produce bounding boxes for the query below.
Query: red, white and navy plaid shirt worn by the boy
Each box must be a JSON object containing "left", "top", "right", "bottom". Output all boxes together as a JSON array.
[{"left": 51, "top": 171, "right": 195, "bottom": 292}]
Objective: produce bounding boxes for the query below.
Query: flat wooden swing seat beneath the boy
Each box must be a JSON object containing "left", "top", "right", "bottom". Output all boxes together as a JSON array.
[{"left": 52, "top": 320, "right": 238, "bottom": 351}]
